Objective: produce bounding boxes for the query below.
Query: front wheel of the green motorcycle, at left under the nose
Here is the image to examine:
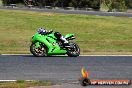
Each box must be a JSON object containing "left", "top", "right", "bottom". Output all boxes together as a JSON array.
[{"left": 30, "top": 43, "right": 47, "bottom": 57}]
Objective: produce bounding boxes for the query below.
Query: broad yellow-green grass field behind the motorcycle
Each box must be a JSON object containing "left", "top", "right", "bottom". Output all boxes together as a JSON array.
[{"left": 0, "top": 10, "right": 132, "bottom": 54}]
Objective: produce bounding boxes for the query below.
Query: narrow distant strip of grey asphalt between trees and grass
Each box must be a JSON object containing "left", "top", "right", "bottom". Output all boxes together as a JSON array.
[{"left": 0, "top": 7, "right": 132, "bottom": 17}]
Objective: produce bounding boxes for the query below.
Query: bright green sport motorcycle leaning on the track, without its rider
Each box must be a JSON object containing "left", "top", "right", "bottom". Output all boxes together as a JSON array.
[{"left": 30, "top": 31, "right": 80, "bottom": 57}]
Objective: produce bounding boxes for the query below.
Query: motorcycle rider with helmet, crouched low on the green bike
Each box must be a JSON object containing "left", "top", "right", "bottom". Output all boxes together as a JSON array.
[{"left": 38, "top": 28, "right": 69, "bottom": 45}]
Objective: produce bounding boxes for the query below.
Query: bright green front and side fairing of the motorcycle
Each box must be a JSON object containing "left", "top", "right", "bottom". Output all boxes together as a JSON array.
[{"left": 32, "top": 33, "right": 67, "bottom": 55}]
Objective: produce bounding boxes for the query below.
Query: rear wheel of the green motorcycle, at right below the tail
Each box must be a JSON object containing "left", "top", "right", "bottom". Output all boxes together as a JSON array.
[{"left": 67, "top": 43, "right": 80, "bottom": 57}]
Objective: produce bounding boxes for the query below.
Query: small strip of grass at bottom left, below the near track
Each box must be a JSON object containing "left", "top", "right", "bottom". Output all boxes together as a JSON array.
[{"left": 0, "top": 81, "right": 51, "bottom": 88}]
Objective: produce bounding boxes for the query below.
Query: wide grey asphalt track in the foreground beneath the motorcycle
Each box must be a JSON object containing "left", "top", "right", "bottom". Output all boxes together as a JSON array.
[{"left": 0, "top": 55, "right": 132, "bottom": 82}]
